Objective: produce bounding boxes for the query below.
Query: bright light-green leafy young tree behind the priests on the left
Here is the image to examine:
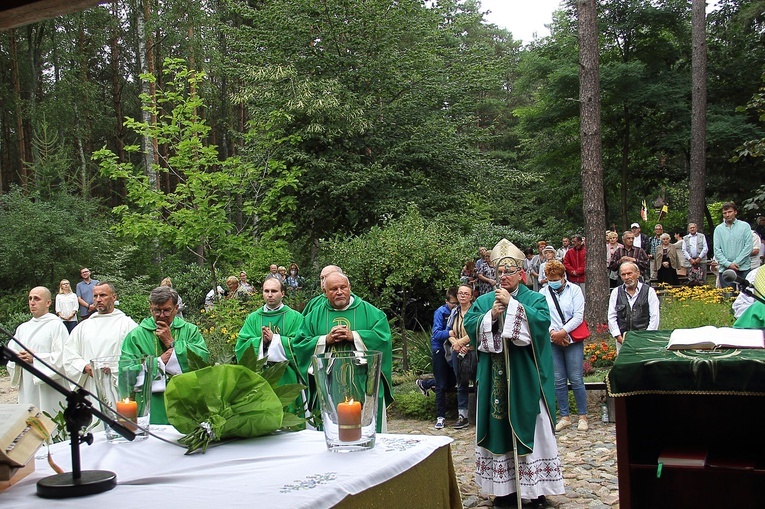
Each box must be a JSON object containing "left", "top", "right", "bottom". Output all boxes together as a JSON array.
[{"left": 93, "top": 59, "right": 262, "bottom": 280}]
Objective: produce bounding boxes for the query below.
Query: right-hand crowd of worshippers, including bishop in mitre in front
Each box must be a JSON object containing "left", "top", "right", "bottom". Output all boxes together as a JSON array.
[{"left": 416, "top": 202, "right": 765, "bottom": 507}]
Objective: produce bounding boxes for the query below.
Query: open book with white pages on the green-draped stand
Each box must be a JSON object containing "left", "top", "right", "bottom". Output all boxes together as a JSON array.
[{"left": 667, "top": 325, "right": 765, "bottom": 350}]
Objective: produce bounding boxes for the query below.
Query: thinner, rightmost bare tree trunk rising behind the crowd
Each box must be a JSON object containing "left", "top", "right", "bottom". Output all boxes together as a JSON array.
[{"left": 688, "top": 0, "right": 707, "bottom": 230}]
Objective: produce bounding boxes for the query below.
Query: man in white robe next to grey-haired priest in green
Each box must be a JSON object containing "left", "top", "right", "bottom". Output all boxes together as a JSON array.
[{"left": 64, "top": 282, "right": 138, "bottom": 394}]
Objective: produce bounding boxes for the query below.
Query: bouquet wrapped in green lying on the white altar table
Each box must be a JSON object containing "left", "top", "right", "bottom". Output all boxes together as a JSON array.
[{"left": 165, "top": 359, "right": 305, "bottom": 454}]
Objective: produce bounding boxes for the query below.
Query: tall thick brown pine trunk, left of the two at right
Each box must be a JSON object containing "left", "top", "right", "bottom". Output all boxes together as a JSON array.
[{"left": 577, "top": 0, "right": 608, "bottom": 324}]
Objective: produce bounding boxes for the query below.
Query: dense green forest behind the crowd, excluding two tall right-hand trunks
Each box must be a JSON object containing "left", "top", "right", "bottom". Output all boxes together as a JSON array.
[{"left": 0, "top": 0, "right": 765, "bottom": 366}]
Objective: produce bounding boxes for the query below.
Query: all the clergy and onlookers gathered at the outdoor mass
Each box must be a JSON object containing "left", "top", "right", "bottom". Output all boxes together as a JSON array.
[{"left": 9, "top": 203, "right": 765, "bottom": 507}]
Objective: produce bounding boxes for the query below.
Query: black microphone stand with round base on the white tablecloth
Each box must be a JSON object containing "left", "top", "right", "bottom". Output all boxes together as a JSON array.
[{"left": 0, "top": 342, "right": 135, "bottom": 498}]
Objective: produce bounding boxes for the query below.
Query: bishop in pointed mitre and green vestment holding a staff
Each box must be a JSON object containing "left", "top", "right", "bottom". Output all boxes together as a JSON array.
[{"left": 464, "top": 239, "right": 565, "bottom": 508}]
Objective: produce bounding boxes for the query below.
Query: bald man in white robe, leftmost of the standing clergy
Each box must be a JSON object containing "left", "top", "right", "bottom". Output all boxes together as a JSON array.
[{"left": 8, "top": 286, "right": 69, "bottom": 416}]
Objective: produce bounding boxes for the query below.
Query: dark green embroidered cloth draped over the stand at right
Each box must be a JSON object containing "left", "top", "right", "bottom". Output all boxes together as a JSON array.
[{"left": 606, "top": 330, "right": 765, "bottom": 397}]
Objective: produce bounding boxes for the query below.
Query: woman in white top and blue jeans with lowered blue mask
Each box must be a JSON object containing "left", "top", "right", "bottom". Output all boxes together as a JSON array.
[{"left": 540, "top": 260, "right": 589, "bottom": 431}]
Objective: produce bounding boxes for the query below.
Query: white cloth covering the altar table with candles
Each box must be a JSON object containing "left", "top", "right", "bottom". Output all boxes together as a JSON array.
[{"left": 0, "top": 426, "right": 452, "bottom": 509}]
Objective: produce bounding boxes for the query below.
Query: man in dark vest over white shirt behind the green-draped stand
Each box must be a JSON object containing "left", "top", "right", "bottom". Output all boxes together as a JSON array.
[{"left": 608, "top": 262, "right": 659, "bottom": 353}]
